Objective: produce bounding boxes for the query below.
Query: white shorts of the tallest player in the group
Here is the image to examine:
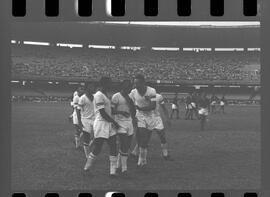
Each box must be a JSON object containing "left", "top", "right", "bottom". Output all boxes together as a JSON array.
[{"left": 137, "top": 115, "right": 164, "bottom": 130}]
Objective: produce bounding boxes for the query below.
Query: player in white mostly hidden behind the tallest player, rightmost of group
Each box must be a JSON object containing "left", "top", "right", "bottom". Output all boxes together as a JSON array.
[{"left": 132, "top": 93, "right": 172, "bottom": 160}]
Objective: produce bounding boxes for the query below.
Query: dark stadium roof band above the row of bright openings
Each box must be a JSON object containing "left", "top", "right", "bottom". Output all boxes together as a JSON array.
[{"left": 11, "top": 21, "right": 260, "bottom": 48}]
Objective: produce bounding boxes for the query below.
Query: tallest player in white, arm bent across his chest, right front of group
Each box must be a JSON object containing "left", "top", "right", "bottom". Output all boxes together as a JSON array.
[{"left": 130, "top": 75, "right": 157, "bottom": 167}]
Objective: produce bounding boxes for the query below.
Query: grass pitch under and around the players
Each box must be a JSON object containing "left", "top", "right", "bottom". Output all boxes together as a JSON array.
[{"left": 12, "top": 103, "right": 261, "bottom": 191}]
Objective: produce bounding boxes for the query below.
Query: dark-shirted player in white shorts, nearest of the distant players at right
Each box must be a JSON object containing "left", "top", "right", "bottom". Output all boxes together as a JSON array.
[{"left": 198, "top": 92, "right": 210, "bottom": 131}]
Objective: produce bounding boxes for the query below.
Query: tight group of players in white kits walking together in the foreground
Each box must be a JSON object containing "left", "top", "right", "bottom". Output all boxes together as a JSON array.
[{"left": 71, "top": 74, "right": 172, "bottom": 177}]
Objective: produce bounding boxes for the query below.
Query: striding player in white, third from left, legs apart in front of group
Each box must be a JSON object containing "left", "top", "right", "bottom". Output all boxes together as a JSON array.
[{"left": 84, "top": 77, "right": 120, "bottom": 177}]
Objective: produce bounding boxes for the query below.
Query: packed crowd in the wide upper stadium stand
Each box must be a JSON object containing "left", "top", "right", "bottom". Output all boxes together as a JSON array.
[{"left": 12, "top": 45, "right": 260, "bottom": 82}]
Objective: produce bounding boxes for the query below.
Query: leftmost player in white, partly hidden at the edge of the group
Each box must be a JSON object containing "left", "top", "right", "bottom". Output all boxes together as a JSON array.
[{"left": 70, "top": 86, "right": 84, "bottom": 148}]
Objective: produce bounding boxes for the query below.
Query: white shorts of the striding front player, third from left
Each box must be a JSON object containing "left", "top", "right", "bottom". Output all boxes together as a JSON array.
[{"left": 93, "top": 120, "right": 116, "bottom": 139}]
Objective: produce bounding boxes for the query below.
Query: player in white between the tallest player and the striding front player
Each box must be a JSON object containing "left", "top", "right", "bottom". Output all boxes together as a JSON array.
[{"left": 112, "top": 80, "right": 136, "bottom": 175}]
